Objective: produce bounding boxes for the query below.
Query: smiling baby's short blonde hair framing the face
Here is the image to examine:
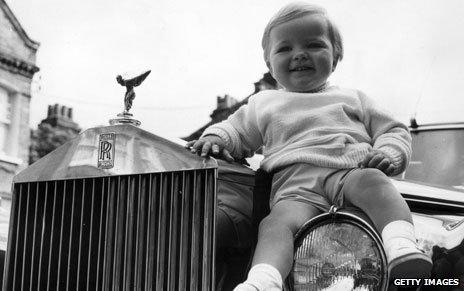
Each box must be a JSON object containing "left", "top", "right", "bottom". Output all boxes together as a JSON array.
[{"left": 261, "top": 2, "right": 343, "bottom": 67}]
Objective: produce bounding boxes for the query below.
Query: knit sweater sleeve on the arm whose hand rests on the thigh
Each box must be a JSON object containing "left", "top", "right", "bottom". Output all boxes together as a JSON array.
[{"left": 359, "top": 92, "right": 411, "bottom": 175}]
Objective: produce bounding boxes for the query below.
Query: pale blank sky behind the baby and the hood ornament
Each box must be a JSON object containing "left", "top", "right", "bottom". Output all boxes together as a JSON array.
[{"left": 6, "top": 0, "right": 464, "bottom": 137}]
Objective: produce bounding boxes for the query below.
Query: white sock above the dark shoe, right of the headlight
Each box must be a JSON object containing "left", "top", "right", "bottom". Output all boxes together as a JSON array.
[{"left": 382, "top": 220, "right": 420, "bottom": 262}]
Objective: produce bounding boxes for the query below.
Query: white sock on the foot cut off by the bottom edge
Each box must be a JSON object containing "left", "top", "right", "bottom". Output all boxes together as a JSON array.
[{"left": 234, "top": 264, "right": 282, "bottom": 291}]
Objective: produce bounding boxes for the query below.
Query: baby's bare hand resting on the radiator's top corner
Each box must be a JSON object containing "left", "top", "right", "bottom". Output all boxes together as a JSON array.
[{"left": 185, "top": 135, "right": 234, "bottom": 162}]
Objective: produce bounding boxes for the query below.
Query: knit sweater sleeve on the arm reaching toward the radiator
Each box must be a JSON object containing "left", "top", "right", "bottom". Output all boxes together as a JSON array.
[{"left": 202, "top": 96, "right": 263, "bottom": 159}]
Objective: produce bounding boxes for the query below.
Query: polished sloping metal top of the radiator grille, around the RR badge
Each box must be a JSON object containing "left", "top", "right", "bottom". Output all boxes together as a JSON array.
[{"left": 13, "top": 125, "right": 218, "bottom": 183}]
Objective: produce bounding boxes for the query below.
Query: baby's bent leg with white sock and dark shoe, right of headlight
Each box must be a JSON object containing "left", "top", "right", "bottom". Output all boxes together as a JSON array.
[{"left": 342, "top": 169, "right": 432, "bottom": 278}]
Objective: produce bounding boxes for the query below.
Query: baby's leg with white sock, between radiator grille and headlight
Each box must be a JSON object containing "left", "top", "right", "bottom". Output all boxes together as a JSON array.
[{"left": 235, "top": 200, "right": 320, "bottom": 290}]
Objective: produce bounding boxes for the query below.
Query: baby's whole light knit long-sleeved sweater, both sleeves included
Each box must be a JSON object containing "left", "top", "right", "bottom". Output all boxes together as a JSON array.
[{"left": 203, "top": 86, "right": 411, "bottom": 175}]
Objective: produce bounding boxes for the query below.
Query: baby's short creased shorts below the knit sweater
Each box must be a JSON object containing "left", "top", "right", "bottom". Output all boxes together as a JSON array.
[{"left": 270, "top": 163, "right": 358, "bottom": 212}]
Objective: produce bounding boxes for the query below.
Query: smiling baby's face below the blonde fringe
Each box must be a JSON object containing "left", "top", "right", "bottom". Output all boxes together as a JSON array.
[{"left": 268, "top": 15, "right": 334, "bottom": 92}]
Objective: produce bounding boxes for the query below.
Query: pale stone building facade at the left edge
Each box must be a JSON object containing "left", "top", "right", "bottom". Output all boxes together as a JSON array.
[{"left": 0, "top": 0, "right": 39, "bottom": 198}]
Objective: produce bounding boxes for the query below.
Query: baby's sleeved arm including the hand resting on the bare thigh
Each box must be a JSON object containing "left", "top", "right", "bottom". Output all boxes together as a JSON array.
[{"left": 360, "top": 93, "right": 411, "bottom": 175}]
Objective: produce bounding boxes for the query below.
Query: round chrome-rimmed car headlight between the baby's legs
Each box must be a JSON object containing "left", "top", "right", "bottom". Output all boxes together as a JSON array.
[{"left": 289, "top": 212, "right": 388, "bottom": 290}]
